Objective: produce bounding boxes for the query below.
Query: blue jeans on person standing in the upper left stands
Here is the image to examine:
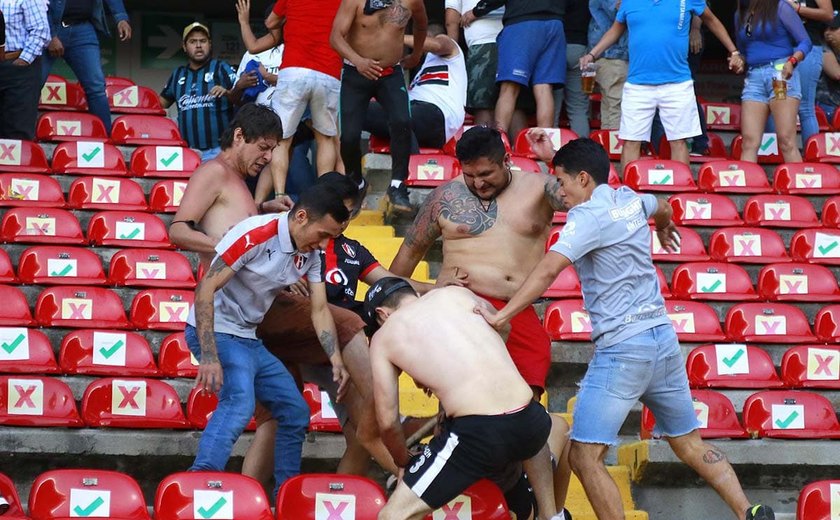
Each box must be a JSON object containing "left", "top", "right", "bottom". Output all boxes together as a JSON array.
[{"left": 41, "top": 22, "right": 111, "bottom": 135}]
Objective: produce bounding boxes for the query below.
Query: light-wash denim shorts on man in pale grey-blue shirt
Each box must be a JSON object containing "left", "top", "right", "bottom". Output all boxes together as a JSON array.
[{"left": 571, "top": 323, "right": 700, "bottom": 445}]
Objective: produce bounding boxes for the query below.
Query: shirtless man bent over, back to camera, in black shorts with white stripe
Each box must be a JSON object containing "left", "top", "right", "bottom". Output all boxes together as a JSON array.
[{"left": 364, "top": 278, "right": 563, "bottom": 520}]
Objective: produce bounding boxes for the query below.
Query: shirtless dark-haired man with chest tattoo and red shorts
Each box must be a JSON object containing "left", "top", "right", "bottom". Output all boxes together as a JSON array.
[{"left": 389, "top": 127, "right": 563, "bottom": 397}]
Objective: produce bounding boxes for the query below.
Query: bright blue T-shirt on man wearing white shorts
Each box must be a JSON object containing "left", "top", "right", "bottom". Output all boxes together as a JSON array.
[{"left": 616, "top": 0, "right": 706, "bottom": 85}]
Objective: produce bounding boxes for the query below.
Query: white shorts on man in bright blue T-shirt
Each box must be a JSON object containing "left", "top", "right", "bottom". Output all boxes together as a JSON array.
[{"left": 618, "top": 80, "right": 703, "bottom": 141}]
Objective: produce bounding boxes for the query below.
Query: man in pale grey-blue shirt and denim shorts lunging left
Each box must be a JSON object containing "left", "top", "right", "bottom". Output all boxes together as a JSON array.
[{"left": 476, "top": 129, "right": 775, "bottom": 520}]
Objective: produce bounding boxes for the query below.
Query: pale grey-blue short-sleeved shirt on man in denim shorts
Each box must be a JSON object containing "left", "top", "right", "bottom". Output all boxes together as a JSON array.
[{"left": 551, "top": 185, "right": 671, "bottom": 347}]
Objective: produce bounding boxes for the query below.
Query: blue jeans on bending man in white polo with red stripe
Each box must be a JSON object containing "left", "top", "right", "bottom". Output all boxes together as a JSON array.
[{"left": 185, "top": 325, "right": 309, "bottom": 494}]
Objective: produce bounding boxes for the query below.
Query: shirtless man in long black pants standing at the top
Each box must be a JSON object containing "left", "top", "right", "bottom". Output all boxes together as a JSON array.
[{"left": 330, "top": 0, "right": 427, "bottom": 212}]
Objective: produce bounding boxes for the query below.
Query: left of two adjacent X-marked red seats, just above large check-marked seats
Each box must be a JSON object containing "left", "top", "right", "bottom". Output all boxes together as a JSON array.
[{"left": 35, "top": 285, "right": 129, "bottom": 329}]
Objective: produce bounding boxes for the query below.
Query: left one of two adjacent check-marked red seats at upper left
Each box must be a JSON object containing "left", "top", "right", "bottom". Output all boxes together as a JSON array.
[{"left": 52, "top": 141, "right": 128, "bottom": 176}]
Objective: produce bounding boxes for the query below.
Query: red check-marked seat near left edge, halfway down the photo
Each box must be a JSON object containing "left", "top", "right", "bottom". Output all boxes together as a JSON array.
[{"left": 18, "top": 246, "right": 105, "bottom": 285}]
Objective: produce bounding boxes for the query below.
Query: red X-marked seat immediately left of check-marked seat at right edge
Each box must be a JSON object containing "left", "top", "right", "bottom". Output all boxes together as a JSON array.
[{"left": 709, "top": 227, "right": 790, "bottom": 264}]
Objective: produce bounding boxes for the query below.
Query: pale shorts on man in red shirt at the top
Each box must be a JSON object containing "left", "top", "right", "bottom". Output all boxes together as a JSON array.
[{"left": 271, "top": 67, "right": 341, "bottom": 139}]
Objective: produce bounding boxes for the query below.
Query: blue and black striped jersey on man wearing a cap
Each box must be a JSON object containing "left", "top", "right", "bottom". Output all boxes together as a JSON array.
[{"left": 160, "top": 59, "right": 236, "bottom": 150}]
